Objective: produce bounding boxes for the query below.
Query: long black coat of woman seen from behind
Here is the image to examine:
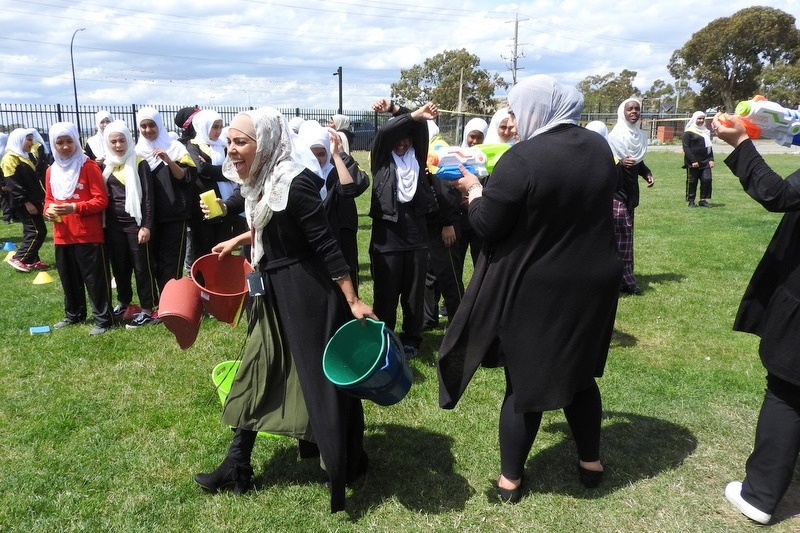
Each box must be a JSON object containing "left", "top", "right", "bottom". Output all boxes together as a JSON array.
[{"left": 438, "top": 125, "right": 621, "bottom": 412}]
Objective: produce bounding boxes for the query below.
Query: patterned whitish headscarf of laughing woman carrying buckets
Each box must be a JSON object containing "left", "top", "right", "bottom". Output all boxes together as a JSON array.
[{"left": 222, "top": 107, "right": 310, "bottom": 264}]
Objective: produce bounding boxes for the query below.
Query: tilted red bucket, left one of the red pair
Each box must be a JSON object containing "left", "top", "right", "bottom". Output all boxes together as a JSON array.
[{"left": 158, "top": 278, "right": 203, "bottom": 350}]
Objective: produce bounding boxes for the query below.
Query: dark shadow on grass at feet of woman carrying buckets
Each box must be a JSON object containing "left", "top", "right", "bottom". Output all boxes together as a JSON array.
[{"left": 255, "top": 424, "right": 474, "bottom": 520}]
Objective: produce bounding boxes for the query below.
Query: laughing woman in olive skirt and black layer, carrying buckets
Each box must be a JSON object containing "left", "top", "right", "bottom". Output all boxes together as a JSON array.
[{"left": 195, "top": 108, "right": 375, "bottom": 512}]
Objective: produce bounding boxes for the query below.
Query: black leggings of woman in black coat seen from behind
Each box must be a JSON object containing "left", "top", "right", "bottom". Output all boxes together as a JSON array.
[{"left": 500, "top": 369, "right": 603, "bottom": 480}]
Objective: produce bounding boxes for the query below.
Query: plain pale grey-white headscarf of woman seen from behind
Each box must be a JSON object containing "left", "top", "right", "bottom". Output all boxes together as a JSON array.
[{"left": 508, "top": 74, "right": 583, "bottom": 141}]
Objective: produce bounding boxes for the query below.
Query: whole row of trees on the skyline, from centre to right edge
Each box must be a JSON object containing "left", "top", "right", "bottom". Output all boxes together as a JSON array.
[{"left": 391, "top": 6, "right": 800, "bottom": 115}]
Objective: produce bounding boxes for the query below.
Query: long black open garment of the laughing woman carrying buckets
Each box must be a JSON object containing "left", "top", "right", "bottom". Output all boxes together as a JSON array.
[{"left": 226, "top": 170, "right": 364, "bottom": 512}]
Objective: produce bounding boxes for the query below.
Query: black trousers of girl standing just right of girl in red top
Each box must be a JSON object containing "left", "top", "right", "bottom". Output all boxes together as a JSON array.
[{"left": 106, "top": 229, "right": 158, "bottom": 309}]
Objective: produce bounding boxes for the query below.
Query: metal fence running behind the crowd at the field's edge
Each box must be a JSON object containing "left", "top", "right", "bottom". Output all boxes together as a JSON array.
[{"left": 0, "top": 103, "right": 689, "bottom": 150}]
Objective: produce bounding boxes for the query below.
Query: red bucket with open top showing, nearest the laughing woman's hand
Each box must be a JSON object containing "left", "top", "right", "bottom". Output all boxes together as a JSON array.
[{"left": 192, "top": 254, "right": 253, "bottom": 326}]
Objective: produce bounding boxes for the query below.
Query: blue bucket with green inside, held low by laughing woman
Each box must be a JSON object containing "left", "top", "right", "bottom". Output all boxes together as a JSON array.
[{"left": 322, "top": 318, "right": 412, "bottom": 405}]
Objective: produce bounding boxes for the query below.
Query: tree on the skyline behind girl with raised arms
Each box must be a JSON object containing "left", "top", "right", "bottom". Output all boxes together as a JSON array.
[{"left": 391, "top": 48, "right": 508, "bottom": 114}]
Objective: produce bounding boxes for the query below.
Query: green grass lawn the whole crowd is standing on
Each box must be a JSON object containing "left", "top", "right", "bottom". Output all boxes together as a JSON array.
[{"left": 0, "top": 148, "right": 800, "bottom": 532}]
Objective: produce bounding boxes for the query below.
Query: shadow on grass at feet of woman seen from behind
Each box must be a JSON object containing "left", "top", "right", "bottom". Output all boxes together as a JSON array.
[{"left": 524, "top": 412, "right": 697, "bottom": 498}]
